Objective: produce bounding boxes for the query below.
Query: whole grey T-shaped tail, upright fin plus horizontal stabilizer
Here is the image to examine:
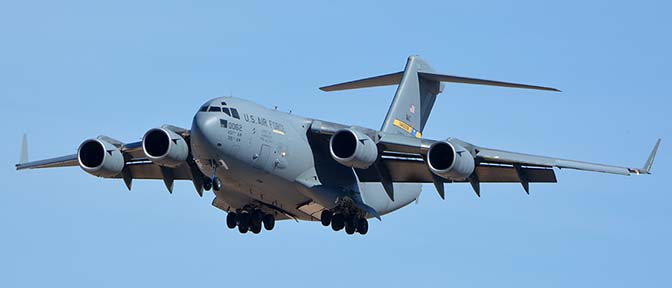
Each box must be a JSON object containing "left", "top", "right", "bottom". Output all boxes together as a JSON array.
[{"left": 320, "top": 56, "right": 560, "bottom": 138}]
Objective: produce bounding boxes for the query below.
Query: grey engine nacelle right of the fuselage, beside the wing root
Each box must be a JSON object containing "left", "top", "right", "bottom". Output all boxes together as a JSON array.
[{"left": 329, "top": 129, "right": 378, "bottom": 169}]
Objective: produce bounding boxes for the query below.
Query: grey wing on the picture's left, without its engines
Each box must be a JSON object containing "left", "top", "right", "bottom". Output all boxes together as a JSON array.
[{"left": 16, "top": 126, "right": 203, "bottom": 196}]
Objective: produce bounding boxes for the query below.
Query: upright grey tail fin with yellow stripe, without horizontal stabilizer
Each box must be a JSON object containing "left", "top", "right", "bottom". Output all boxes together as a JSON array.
[{"left": 381, "top": 56, "right": 443, "bottom": 138}]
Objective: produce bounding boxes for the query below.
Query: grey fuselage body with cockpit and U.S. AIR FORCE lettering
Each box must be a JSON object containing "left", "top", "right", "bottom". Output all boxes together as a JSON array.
[{"left": 191, "top": 97, "right": 420, "bottom": 220}]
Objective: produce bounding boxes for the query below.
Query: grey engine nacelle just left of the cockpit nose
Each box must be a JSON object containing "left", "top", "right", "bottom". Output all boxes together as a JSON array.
[{"left": 142, "top": 128, "right": 189, "bottom": 168}]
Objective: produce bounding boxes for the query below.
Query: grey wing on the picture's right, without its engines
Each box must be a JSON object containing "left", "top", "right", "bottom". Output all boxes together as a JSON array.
[{"left": 311, "top": 121, "right": 660, "bottom": 197}]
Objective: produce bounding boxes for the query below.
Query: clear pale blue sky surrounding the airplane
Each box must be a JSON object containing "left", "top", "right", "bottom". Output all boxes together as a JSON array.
[{"left": 0, "top": 1, "right": 672, "bottom": 287}]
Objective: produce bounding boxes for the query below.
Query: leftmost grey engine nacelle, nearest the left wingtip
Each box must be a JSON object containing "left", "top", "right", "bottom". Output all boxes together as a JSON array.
[{"left": 77, "top": 139, "right": 126, "bottom": 177}]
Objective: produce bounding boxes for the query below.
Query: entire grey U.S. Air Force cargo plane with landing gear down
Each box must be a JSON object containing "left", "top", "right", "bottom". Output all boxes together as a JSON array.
[{"left": 16, "top": 56, "right": 660, "bottom": 235}]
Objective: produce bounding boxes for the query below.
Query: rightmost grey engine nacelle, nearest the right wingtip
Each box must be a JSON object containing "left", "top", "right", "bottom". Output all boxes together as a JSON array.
[{"left": 427, "top": 142, "right": 476, "bottom": 180}]
